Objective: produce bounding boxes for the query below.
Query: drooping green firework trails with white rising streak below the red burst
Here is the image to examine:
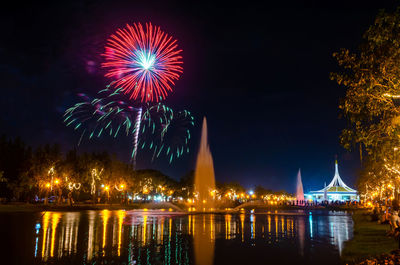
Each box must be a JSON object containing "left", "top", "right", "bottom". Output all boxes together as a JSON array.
[{"left": 64, "top": 88, "right": 194, "bottom": 166}]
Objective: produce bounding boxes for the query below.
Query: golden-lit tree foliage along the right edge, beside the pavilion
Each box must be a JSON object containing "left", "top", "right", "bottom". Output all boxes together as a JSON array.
[{"left": 331, "top": 8, "right": 400, "bottom": 199}]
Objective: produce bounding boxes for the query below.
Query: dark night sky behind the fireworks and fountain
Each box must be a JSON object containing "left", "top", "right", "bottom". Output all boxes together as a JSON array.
[{"left": 0, "top": 0, "right": 398, "bottom": 192}]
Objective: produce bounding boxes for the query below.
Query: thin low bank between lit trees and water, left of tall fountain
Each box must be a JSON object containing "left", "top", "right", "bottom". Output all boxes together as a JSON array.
[{"left": 0, "top": 202, "right": 183, "bottom": 213}]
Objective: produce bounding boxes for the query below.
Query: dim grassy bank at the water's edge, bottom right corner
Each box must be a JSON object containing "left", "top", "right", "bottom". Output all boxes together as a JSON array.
[{"left": 342, "top": 211, "right": 398, "bottom": 264}]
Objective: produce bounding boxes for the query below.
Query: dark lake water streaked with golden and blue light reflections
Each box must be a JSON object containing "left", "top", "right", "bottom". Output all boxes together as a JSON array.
[{"left": 0, "top": 210, "right": 353, "bottom": 265}]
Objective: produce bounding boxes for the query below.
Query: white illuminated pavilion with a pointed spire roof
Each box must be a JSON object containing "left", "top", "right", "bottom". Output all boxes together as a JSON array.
[{"left": 304, "top": 161, "right": 359, "bottom": 202}]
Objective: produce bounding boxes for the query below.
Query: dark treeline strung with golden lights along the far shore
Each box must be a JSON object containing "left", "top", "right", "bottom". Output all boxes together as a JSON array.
[{"left": 0, "top": 135, "right": 286, "bottom": 203}]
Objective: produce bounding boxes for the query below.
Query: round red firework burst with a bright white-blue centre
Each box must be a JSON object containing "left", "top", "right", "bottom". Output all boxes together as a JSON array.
[{"left": 102, "top": 23, "right": 183, "bottom": 102}]
